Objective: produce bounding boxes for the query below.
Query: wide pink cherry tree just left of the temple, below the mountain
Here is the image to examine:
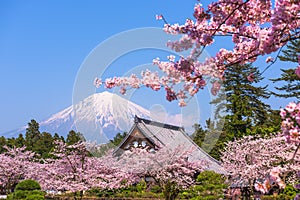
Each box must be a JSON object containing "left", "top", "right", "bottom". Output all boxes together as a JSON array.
[{"left": 26, "top": 142, "right": 136, "bottom": 192}]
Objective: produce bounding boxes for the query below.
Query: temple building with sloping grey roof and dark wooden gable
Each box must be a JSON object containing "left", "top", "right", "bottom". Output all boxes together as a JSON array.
[{"left": 113, "top": 116, "right": 226, "bottom": 174}]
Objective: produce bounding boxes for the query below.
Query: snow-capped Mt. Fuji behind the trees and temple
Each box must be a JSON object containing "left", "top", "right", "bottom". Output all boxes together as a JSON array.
[{"left": 5, "top": 92, "right": 150, "bottom": 143}]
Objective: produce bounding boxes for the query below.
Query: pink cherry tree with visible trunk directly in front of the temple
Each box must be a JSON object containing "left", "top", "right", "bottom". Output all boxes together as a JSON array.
[{"left": 118, "top": 145, "right": 208, "bottom": 199}]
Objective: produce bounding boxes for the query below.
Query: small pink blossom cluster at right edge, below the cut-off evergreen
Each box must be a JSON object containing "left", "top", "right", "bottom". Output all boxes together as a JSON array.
[{"left": 280, "top": 102, "right": 300, "bottom": 145}]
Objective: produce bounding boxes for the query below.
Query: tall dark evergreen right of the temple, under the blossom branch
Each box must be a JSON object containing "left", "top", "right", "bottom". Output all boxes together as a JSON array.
[{"left": 211, "top": 64, "right": 271, "bottom": 139}]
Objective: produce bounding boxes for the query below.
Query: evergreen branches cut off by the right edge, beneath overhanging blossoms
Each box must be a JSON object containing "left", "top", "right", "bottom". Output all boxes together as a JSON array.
[{"left": 270, "top": 39, "right": 300, "bottom": 101}]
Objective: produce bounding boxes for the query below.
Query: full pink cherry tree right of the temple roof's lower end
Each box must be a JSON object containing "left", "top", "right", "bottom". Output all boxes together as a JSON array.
[{"left": 222, "top": 136, "right": 300, "bottom": 193}]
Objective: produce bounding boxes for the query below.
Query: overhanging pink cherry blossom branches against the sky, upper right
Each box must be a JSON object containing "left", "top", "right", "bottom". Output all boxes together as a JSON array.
[{"left": 95, "top": 0, "right": 300, "bottom": 106}]
